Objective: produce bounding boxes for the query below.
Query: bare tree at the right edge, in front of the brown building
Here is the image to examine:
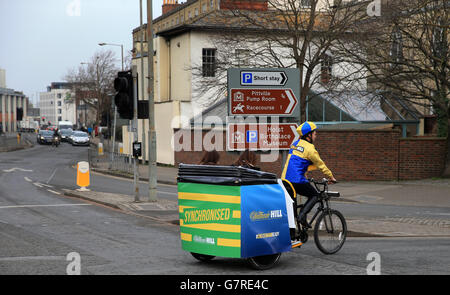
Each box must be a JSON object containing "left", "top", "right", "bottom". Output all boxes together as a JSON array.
[{"left": 340, "top": 0, "right": 450, "bottom": 166}]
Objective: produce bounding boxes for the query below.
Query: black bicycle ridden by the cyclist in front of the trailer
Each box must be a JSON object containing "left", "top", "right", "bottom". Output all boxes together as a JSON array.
[{"left": 283, "top": 178, "right": 347, "bottom": 254}]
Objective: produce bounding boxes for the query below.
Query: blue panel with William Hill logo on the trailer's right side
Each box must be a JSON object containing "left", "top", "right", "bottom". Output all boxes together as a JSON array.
[{"left": 241, "top": 184, "right": 291, "bottom": 258}]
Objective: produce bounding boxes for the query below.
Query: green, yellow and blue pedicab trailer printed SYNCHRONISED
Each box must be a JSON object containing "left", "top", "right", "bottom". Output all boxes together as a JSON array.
[{"left": 177, "top": 164, "right": 291, "bottom": 269}]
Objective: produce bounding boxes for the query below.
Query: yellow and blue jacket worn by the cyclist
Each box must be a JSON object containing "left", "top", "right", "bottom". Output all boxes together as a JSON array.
[{"left": 281, "top": 139, "right": 333, "bottom": 183}]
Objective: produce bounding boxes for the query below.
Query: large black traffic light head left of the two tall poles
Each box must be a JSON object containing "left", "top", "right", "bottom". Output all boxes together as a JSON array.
[{"left": 114, "top": 71, "right": 134, "bottom": 120}]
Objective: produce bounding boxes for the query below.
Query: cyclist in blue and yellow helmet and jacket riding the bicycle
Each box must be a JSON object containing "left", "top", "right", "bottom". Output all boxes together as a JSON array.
[{"left": 281, "top": 122, "right": 336, "bottom": 228}]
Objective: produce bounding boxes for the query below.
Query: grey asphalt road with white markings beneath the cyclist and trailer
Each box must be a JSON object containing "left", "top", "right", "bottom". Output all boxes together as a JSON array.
[{"left": 0, "top": 144, "right": 450, "bottom": 275}]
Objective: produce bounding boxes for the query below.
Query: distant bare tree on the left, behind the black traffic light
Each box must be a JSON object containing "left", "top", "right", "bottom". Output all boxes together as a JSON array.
[{"left": 64, "top": 50, "right": 119, "bottom": 125}]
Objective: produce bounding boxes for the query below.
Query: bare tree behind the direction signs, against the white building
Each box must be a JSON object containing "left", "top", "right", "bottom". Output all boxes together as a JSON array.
[{"left": 192, "top": 0, "right": 368, "bottom": 121}]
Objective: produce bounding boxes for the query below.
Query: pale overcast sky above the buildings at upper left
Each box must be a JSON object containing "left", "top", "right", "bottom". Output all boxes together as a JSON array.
[{"left": 0, "top": 0, "right": 164, "bottom": 106}]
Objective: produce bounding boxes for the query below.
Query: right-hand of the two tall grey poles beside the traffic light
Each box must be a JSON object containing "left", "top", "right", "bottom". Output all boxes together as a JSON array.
[{"left": 147, "top": 0, "right": 157, "bottom": 202}]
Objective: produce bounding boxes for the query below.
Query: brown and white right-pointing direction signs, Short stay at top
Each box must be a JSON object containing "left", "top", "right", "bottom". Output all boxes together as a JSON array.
[{"left": 227, "top": 68, "right": 300, "bottom": 158}]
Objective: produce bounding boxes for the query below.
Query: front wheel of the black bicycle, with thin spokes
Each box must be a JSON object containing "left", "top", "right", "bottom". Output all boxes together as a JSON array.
[{"left": 314, "top": 210, "right": 347, "bottom": 254}]
